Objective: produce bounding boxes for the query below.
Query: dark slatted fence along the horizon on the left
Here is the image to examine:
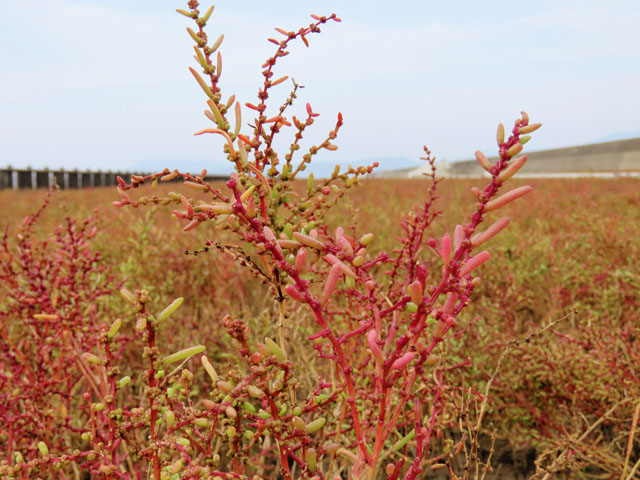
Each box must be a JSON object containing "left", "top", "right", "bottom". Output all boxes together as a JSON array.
[{"left": 0, "top": 167, "right": 226, "bottom": 190}]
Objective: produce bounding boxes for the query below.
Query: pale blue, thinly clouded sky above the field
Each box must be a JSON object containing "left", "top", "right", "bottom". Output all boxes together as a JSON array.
[{"left": 0, "top": 0, "right": 640, "bottom": 172}]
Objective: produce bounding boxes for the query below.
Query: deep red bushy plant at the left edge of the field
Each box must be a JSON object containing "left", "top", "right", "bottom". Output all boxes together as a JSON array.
[{"left": 0, "top": 191, "right": 120, "bottom": 476}]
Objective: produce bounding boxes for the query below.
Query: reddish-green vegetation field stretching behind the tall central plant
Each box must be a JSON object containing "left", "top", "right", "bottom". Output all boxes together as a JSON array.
[{"left": 0, "top": 180, "right": 640, "bottom": 478}]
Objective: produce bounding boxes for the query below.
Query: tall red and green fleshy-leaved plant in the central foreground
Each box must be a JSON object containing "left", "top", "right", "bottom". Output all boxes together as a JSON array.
[{"left": 0, "top": 0, "right": 540, "bottom": 480}]
